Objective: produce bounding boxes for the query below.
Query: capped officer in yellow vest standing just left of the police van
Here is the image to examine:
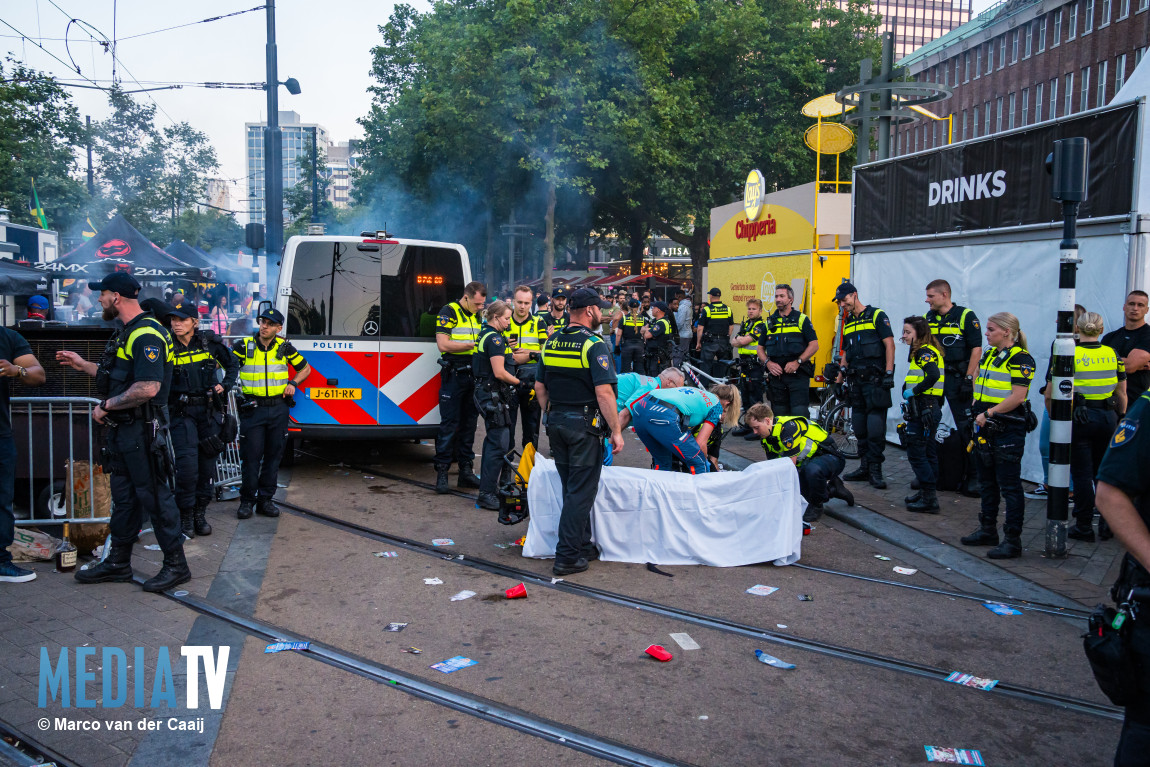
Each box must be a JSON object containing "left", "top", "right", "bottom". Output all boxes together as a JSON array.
[{"left": 231, "top": 307, "right": 312, "bottom": 520}]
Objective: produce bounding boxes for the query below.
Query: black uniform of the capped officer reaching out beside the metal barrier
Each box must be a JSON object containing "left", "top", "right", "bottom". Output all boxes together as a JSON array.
[{"left": 76, "top": 312, "right": 191, "bottom": 591}]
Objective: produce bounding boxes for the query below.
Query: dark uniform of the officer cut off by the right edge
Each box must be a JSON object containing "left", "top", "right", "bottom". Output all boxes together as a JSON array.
[{"left": 1098, "top": 392, "right": 1150, "bottom": 767}]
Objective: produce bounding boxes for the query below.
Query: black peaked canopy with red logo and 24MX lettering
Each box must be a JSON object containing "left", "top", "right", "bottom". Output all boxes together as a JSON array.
[{"left": 36, "top": 215, "right": 201, "bottom": 279}]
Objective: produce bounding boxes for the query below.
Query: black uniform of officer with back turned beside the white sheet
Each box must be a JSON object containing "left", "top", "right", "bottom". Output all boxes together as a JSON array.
[{"left": 539, "top": 325, "right": 618, "bottom": 567}]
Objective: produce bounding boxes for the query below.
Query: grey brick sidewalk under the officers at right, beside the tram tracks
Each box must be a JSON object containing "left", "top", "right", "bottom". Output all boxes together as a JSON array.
[{"left": 723, "top": 437, "right": 1122, "bottom": 607}]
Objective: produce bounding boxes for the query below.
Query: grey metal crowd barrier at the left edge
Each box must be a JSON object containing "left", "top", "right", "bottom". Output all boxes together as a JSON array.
[{"left": 12, "top": 397, "right": 112, "bottom": 524}]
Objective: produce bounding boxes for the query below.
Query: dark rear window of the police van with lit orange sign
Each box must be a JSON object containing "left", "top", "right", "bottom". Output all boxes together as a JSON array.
[{"left": 288, "top": 240, "right": 463, "bottom": 338}]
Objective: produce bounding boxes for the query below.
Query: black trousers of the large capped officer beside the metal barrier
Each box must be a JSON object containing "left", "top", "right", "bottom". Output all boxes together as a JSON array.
[{"left": 107, "top": 420, "right": 184, "bottom": 554}]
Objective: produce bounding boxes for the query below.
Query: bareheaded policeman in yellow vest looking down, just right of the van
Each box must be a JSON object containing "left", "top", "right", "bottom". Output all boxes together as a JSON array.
[{"left": 435, "top": 282, "right": 488, "bottom": 494}]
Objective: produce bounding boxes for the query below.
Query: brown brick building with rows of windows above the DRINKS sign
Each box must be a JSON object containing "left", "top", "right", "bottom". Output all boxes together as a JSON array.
[{"left": 894, "top": 0, "right": 1150, "bottom": 154}]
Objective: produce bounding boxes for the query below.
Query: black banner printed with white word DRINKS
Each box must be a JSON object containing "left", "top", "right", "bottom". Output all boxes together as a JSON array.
[{"left": 852, "top": 103, "right": 1139, "bottom": 244}]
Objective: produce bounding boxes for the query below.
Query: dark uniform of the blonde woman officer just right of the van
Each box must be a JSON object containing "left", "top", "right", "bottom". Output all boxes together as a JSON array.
[{"left": 472, "top": 325, "right": 512, "bottom": 511}]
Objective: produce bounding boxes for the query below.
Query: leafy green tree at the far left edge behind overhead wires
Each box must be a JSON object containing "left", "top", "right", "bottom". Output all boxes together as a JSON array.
[{"left": 0, "top": 59, "right": 87, "bottom": 231}]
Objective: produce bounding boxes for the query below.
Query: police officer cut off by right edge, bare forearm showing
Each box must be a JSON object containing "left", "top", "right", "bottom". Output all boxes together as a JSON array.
[{"left": 1094, "top": 392, "right": 1150, "bottom": 767}]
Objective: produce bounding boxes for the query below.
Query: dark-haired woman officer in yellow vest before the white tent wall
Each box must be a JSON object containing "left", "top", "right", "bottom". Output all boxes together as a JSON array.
[{"left": 903, "top": 317, "right": 946, "bottom": 514}]
